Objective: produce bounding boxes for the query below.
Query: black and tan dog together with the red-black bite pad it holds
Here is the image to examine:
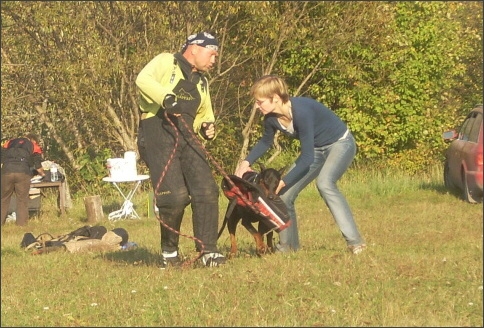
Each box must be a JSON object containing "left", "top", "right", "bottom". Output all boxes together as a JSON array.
[{"left": 218, "top": 166, "right": 290, "bottom": 256}]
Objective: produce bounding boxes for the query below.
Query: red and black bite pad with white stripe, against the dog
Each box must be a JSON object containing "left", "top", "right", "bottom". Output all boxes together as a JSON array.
[{"left": 221, "top": 173, "right": 291, "bottom": 233}]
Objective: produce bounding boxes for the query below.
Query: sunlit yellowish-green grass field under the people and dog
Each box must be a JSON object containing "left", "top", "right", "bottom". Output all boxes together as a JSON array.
[{"left": 1, "top": 165, "right": 483, "bottom": 327}]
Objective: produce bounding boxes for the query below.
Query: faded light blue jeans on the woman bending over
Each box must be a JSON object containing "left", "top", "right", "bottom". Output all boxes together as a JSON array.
[{"left": 277, "top": 133, "right": 364, "bottom": 252}]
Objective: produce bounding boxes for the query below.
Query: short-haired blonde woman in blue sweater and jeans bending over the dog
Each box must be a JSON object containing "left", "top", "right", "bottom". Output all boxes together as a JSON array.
[{"left": 235, "top": 75, "right": 366, "bottom": 254}]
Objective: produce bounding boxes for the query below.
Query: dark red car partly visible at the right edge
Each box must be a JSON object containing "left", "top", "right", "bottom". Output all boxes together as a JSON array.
[{"left": 442, "top": 105, "right": 483, "bottom": 203}]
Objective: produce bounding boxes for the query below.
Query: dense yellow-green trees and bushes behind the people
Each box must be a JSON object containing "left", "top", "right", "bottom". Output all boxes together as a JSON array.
[{"left": 1, "top": 1, "right": 483, "bottom": 196}]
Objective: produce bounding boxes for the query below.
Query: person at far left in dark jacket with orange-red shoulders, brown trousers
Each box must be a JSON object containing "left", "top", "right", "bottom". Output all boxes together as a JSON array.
[{"left": 1, "top": 134, "right": 45, "bottom": 226}]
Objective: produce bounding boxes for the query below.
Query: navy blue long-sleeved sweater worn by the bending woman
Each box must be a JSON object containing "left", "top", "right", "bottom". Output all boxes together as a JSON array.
[{"left": 245, "top": 97, "right": 347, "bottom": 186}]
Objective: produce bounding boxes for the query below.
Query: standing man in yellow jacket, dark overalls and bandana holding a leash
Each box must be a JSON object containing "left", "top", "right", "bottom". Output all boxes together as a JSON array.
[{"left": 136, "top": 32, "right": 225, "bottom": 266}]
